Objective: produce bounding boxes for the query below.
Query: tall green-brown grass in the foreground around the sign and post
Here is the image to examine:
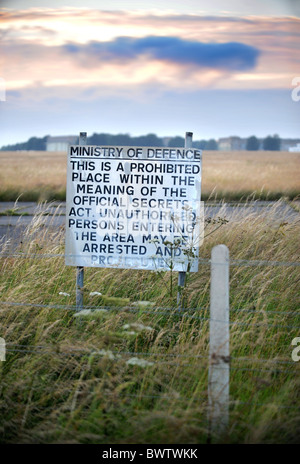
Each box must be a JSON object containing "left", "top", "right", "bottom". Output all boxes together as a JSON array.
[{"left": 0, "top": 202, "right": 300, "bottom": 444}]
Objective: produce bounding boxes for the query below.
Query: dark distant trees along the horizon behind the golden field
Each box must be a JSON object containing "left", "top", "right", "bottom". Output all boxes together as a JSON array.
[{"left": 0, "top": 133, "right": 281, "bottom": 151}]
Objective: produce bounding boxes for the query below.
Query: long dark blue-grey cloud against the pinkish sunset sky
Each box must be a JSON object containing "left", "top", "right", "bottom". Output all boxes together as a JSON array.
[{"left": 63, "top": 36, "right": 260, "bottom": 71}]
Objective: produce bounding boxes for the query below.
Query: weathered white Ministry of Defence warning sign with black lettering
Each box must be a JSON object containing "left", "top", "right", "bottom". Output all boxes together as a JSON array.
[{"left": 65, "top": 145, "right": 203, "bottom": 272}]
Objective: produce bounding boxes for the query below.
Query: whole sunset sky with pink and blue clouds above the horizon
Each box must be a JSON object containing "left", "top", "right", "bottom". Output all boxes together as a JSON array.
[{"left": 0, "top": 0, "right": 300, "bottom": 147}]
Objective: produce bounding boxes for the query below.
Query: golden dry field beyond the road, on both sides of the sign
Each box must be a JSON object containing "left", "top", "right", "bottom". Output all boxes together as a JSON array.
[{"left": 0, "top": 151, "right": 300, "bottom": 201}]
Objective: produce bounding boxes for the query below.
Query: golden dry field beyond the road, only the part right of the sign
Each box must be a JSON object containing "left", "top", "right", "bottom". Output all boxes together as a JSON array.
[{"left": 202, "top": 151, "right": 300, "bottom": 200}]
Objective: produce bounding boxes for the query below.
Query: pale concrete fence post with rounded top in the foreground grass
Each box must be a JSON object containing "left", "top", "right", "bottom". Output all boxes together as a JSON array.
[{"left": 208, "top": 245, "right": 230, "bottom": 436}]
